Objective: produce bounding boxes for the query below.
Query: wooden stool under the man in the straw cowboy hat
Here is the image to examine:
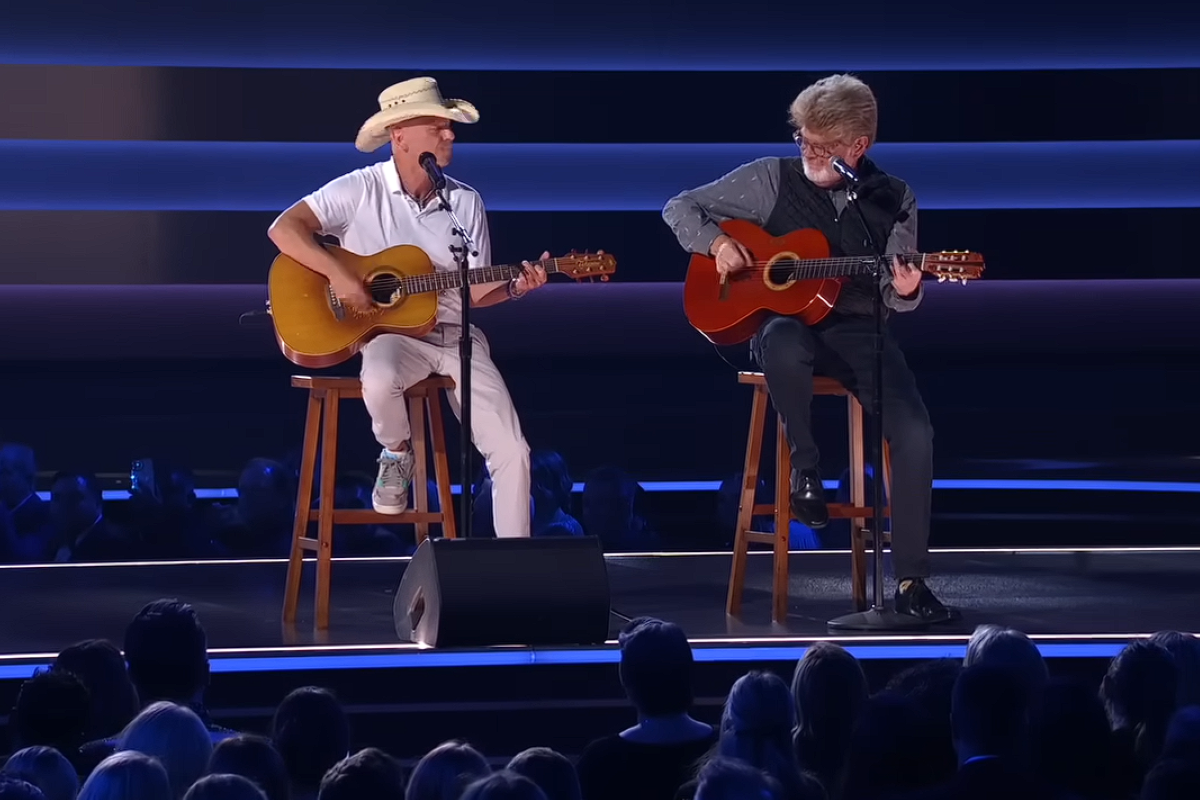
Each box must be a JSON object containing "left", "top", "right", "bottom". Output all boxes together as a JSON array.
[{"left": 283, "top": 375, "right": 458, "bottom": 628}]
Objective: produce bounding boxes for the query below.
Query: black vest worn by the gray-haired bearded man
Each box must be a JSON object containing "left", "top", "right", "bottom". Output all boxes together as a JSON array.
[{"left": 763, "top": 157, "right": 906, "bottom": 317}]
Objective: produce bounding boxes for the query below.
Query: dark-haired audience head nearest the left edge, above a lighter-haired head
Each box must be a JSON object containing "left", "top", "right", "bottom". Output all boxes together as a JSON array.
[{"left": 10, "top": 669, "right": 90, "bottom": 753}]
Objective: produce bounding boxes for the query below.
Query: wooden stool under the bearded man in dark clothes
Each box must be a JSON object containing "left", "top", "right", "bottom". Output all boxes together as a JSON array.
[{"left": 725, "top": 372, "right": 892, "bottom": 622}]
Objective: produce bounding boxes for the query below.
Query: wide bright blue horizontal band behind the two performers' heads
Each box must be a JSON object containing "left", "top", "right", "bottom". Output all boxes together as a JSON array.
[{"left": 0, "top": 140, "right": 1200, "bottom": 212}]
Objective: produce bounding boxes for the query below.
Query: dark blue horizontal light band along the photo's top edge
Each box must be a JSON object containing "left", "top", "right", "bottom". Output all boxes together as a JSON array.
[{"left": 0, "top": 6, "right": 1200, "bottom": 71}]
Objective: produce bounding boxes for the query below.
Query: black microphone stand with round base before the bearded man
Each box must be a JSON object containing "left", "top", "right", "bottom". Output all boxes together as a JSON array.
[{"left": 827, "top": 164, "right": 929, "bottom": 631}]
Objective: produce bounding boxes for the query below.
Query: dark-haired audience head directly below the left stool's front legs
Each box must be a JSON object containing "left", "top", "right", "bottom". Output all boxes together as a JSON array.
[{"left": 271, "top": 686, "right": 350, "bottom": 790}]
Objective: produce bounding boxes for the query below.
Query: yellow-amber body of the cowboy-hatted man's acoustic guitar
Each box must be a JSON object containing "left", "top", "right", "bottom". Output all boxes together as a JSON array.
[{"left": 268, "top": 245, "right": 438, "bottom": 368}]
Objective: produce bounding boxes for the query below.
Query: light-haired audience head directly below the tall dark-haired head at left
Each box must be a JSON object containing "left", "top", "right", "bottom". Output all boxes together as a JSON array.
[{"left": 116, "top": 700, "right": 212, "bottom": 798}]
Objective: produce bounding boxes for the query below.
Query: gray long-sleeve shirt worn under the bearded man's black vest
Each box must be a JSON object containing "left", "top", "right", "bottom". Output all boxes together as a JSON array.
[{"left": 662, "top": 157, "right": 925, "bottom": 312}]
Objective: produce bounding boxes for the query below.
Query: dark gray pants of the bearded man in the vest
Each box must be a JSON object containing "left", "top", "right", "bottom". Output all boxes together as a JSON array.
[{"left": 751, "top": 315, "right": 934, "bottom": 581}]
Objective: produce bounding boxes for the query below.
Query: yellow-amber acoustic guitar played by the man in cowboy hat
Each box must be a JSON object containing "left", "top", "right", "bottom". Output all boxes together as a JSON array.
[{"left": 266, "top": 245, "right": 617, "bottom": 368}]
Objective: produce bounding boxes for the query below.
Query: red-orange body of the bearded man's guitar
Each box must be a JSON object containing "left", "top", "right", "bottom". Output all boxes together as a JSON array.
[{"left": 683, "top": 219, "right": 845, "bottom": 345}]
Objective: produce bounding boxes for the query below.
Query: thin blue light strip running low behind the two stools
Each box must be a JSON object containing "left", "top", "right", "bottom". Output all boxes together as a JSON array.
[{"left": 37, "top": 479, "right": 1200, "bottom": 500}]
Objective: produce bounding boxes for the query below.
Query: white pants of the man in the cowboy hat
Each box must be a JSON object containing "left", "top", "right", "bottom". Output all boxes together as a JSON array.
[{"left": 360, "top": 325, "right": 529, "bottom": 536}]
